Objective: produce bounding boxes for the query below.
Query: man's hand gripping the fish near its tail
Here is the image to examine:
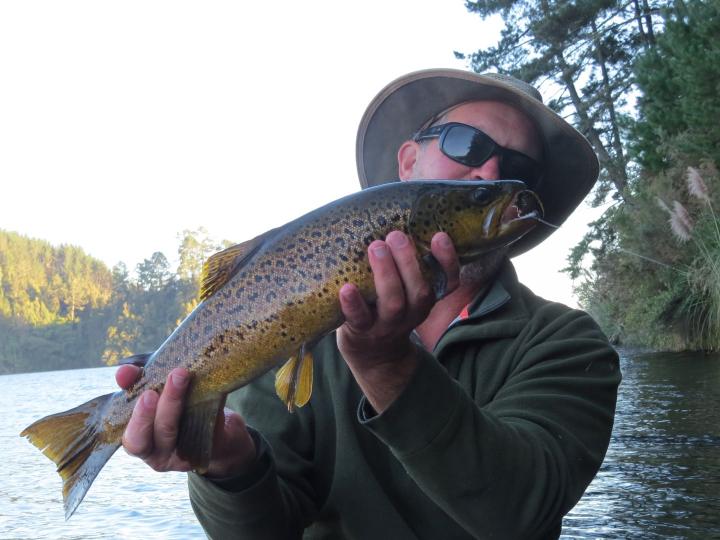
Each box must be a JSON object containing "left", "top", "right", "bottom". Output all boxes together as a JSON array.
[{"left": 115, "top": 365, "right": 256, "bottom": 478}]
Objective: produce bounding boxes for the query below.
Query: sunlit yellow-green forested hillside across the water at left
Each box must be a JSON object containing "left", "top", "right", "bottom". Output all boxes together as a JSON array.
[{"left": 0, "top": 231, "right": 214, "bottom": 373}]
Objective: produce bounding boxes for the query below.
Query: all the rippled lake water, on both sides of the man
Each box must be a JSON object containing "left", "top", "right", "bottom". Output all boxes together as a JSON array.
[{"left": 0, "top": 354, "right": 720, "bottom": 540}]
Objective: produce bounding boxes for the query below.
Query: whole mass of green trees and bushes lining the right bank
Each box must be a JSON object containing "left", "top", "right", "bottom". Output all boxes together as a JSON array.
[{"left": 567, "top": 2, "right": 720, "bottom": 350}]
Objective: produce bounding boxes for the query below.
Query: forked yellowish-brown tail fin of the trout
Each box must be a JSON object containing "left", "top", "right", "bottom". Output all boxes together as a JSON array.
[{"left": 20, "top": 394, "right": 120, "bottom": 519}]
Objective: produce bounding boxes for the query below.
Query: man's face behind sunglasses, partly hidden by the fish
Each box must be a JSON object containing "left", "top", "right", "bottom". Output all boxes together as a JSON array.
[{"left": 398, "top": 101, "right": 542, "bottom": 184}]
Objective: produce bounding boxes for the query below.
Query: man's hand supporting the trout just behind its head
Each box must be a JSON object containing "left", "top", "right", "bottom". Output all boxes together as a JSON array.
[{"left": 337, "top": 231, "right": 459, "bottom": 413}]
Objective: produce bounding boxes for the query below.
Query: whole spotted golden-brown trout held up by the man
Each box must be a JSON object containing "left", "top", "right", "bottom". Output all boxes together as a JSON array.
[{"left": 21, "top": 180, "right": 542, "bottom": 519}]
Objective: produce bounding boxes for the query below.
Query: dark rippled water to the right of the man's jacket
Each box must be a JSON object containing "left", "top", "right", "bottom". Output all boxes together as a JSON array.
[{"left": 562, "top": 354, "right": 720, "bottom": 539}]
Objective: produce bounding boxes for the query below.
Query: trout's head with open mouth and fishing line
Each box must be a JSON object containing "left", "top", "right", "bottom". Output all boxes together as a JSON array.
[{"left": 409, "top": 180, "right": 543, "bottom": 264}]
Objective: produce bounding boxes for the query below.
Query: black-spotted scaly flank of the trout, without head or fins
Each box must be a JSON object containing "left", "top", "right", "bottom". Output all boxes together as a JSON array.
[{"left": 99, "top": 186, "right": 420, "bottom": 436}]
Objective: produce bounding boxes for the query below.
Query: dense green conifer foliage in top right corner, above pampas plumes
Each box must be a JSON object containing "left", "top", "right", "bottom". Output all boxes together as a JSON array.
[{"left": 630, "top": 2, "right": 720, "bottom": 174}]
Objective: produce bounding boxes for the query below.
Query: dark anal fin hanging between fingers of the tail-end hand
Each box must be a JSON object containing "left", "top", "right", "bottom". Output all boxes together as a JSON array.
[{"left": 177, "top": 396, "right": 222, "bottom": 473}]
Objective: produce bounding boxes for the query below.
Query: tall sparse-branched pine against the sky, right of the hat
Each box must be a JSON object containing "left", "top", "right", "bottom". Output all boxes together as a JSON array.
[{"left": 456, "top": 0, "right": 655, "bottom": 202}]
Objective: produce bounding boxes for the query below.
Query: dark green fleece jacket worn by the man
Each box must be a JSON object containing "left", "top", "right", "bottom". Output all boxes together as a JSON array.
[{"left": 189, "top": 262, "right": 620, "bottom": 540}]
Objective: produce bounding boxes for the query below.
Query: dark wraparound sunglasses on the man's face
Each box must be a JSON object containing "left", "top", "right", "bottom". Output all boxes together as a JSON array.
[{"left": 413, "top": 122, "right": 542, "bottom": 189}]
